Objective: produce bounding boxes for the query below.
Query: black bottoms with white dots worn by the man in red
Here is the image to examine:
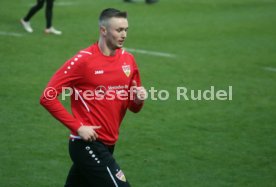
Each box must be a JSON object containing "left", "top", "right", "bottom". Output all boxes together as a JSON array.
[{"left": 65, "top": 139, "right": 130, "bottom": 187}]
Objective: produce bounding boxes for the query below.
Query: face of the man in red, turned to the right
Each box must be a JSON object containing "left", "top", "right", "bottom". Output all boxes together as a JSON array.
[{"left": 105, "top": 18, "right": 128, "bottom": 50}]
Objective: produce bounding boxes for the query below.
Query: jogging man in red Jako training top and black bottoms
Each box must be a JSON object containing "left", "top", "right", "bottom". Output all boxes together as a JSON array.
[{"left": 40, "top": 8, "right": 146, "bottom": 187}]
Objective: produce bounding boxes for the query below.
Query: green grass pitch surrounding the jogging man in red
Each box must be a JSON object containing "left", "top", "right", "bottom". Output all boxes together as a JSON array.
[{"left": 0, "top": 0, "right": 276, "bottom": 187}]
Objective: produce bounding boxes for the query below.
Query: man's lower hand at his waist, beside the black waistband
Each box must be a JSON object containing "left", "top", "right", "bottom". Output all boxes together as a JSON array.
[{"left": 77, "top": 125, "right": 101, "bottom": 142}]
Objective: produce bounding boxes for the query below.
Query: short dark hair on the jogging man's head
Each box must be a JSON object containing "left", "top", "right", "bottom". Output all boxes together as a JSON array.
[{"left": 99, "top": 8, "right": 127, "bottom": 25}]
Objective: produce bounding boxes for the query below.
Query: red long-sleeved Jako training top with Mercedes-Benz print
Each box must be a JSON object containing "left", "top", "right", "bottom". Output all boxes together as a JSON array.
[{"left": 40, "top": 43, "right": 143, "bottom": 145}]
